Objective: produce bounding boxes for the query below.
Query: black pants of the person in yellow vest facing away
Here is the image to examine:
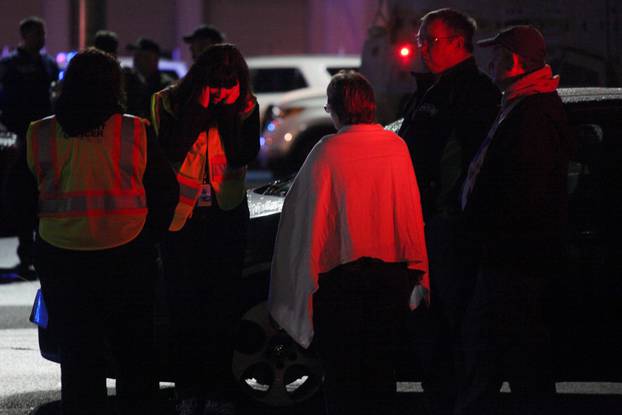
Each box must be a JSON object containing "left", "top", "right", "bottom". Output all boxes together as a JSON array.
[{"left": 35, "top": 236, "right": 158, "bottom": 415}]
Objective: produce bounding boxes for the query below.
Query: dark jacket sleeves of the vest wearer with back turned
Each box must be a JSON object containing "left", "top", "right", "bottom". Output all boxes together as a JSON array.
[{"left": 2, "top": 120, "right": 179, "bottom": 242}]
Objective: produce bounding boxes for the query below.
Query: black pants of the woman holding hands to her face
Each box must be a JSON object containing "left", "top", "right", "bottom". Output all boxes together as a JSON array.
[{"left": 162, "top": 200, "right": 249, "bottom": 399}]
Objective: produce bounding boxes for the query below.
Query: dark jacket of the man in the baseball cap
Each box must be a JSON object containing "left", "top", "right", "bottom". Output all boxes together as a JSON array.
[{"left": 464, "top": 92, "right": 576, "bottom": 269}]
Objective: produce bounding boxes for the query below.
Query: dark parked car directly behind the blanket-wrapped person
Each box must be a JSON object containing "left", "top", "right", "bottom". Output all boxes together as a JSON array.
[{"left": 35, "top": 88, "right": 622, "bottom": 405}]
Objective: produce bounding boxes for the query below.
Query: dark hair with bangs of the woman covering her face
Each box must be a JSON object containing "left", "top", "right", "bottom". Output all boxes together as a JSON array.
[{"left": 172, "top": 43, "right": 251, "bottom": 112}]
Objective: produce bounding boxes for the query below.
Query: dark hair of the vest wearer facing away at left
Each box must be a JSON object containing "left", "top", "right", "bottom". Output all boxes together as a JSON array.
[{"left": 55, "top": 48, "right": 124, "bottom": 136}]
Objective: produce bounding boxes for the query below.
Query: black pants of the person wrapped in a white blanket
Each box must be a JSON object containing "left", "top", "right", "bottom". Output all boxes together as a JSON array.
[{"left": 313, "top": 258, "right": 414, "bottom": 415}]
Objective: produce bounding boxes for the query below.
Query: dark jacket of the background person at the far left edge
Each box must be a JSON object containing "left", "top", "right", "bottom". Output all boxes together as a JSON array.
[{"left": 0, "top": 48, "right": 58, "bottom": 142}]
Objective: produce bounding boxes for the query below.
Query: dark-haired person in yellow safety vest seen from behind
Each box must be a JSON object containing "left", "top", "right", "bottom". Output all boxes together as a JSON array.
[{"left": 4, "top": 48, "right": 179, "bottom": 415}]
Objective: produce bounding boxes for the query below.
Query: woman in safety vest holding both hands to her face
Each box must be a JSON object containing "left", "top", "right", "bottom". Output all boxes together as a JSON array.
[{"left": 152, "top": 44, "right": 259, "bottom": 414}]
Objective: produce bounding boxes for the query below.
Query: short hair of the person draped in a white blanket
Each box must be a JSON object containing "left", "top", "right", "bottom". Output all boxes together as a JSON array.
[{"left": 326, "top": 70, "right": 376, "bottom": 125}]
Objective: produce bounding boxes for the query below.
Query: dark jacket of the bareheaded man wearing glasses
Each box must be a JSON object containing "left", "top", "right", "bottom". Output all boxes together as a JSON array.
[{"left": 398, "top": 58, "right": 501, "bottom": 218}]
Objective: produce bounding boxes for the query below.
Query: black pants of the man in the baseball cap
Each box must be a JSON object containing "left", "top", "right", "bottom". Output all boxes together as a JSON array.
[{"left": 455, "top": 265, "right": 555, "bottom": 415}]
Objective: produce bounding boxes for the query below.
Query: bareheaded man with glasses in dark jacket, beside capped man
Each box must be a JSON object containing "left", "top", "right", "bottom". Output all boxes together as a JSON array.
[{"left": 398, "top": 9, "right": 500, "bottom": 414}]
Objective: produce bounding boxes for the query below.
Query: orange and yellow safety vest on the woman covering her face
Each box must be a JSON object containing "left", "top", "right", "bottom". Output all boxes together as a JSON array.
[{"left": 151, "top": 88, "right": 256, "bottom": 231}]
